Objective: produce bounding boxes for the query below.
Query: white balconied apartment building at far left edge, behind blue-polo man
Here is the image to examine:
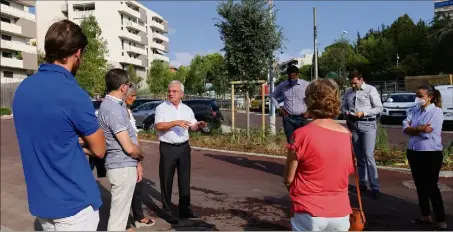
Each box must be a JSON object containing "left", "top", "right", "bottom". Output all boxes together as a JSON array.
[{"left": 0, "top": 0, "right": 38, "bottom": 82}]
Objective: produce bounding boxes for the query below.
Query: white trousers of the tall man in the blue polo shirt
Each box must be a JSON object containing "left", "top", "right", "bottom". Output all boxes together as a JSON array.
[{"left": 38, "top": 206, "right": 99, "bottom": 231}]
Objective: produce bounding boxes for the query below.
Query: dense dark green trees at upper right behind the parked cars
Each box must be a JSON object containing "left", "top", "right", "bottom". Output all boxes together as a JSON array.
[{"left": 319, "top": 14, "right": 453, "bottom": 82}]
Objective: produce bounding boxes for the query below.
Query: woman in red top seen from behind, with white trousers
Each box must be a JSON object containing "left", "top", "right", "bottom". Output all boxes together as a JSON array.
[{"left": 284, "top": 79, "right": 354, "bottom": 231}]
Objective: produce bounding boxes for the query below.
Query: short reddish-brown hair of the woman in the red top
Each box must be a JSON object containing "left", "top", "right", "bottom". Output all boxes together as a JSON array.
[{"left": 305, "top": 79, "right": 341, "bottom": 119}]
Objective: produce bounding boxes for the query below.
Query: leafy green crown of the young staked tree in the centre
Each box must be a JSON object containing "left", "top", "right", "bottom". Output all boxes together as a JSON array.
[{"left": 215, "top": 0, "right": 283, "bottom": 90}]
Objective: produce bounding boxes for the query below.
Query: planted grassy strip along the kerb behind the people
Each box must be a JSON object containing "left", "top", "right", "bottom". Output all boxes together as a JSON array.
[{"left": 139, "top": 128, "right": 453, "bottom": 171}]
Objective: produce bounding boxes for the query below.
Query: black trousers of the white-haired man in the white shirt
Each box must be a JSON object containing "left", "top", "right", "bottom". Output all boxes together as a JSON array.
[{"left": 159, "top": 142, "right": 191, "bottom": 215}]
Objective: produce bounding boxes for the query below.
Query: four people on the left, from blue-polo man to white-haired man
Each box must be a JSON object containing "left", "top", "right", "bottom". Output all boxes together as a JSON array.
[{"left": 13, "top": 20, "right": 203, "bottom": 231}]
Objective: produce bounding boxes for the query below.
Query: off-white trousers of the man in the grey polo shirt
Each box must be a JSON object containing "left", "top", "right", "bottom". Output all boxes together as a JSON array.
[{"left": 107, "top": 167, "right": 137, "bottom": 231}]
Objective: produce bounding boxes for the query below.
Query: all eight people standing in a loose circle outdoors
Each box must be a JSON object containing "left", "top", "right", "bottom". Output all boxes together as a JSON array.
[{"left": 9, "top": 20, "right": 447, "bottom": 231}]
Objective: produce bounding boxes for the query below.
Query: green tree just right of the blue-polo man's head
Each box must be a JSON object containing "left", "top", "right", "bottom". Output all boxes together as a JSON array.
[{"left": 76, "top": 16, "right": 110, "bottom": 96}]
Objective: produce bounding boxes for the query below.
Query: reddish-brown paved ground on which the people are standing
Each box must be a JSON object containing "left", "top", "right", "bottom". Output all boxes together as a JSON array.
[{"left": 0, "top": 120, "right": 453, "bottom": 231}]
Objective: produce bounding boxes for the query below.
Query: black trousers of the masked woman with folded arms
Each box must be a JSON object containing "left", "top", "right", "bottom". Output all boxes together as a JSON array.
[{"left": 407, "top": 150, "right": 445, "bottom": 222}]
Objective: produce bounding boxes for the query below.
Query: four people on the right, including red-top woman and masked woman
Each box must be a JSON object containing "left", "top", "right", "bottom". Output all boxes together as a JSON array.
[{"left": 271, "top": 66, "right": 447, "bottom": 231}]
